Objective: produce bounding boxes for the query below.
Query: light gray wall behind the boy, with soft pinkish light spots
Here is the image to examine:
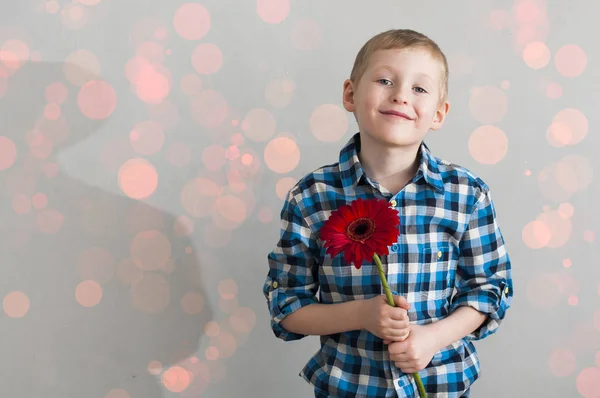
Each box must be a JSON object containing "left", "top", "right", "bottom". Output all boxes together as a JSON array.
[{"left": 0, "top": 0, "right": 600, "bottom": 398}]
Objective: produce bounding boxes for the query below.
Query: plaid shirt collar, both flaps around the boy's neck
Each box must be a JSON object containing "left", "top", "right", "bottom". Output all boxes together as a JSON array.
[{"left": 339, "top": 133, "right": 444, "bottom": 193}]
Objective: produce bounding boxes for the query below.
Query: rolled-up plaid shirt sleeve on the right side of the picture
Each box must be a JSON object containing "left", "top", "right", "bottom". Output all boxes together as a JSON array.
[{"left": 450, "top": 190, "right": 513, "bottom": 340}]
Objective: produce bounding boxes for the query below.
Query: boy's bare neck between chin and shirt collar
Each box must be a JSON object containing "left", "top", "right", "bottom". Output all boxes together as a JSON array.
[{"left": 358, "top": 134, "right": 421, "bottom": 194}]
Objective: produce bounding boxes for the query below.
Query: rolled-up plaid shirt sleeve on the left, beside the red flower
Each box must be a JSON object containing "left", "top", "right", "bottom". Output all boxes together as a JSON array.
[{"left": 263, "top": 192, "right": 319, "bottom": 341}]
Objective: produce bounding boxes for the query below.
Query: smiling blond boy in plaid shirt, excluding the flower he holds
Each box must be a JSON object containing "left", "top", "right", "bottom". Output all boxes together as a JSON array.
[{"left": 263, "top": 30, "right": 513, "bottom": 398}]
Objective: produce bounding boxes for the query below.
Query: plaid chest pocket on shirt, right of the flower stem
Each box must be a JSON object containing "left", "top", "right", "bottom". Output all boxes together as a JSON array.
[{"left": 415, "top": 243, "right": 456, "bottom": 300}]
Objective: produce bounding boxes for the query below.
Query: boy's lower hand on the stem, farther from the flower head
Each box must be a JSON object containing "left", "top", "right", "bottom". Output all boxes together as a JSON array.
[{"left": 388, "top": 324, "right": 439, "bottom": 373}]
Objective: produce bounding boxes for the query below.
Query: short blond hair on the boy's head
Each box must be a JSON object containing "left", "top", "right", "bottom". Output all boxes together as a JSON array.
[{"left": 350, "top": 29, "right": 449, "bottom": 103}]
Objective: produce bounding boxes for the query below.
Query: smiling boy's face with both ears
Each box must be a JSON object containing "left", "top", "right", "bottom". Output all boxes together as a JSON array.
[{"left": 343, "top": 48, "right": 449, "bottom": 147}]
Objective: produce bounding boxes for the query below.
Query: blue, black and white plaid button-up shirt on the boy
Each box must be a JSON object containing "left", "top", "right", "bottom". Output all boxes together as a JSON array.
[{"left": 263, "top": 134, "right": 513, "bottom": 398}]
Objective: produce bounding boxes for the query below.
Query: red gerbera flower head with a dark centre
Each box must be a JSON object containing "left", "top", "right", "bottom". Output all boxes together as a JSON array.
[{"left": 321, "top": 199, "right": 400, "bottom": 269}]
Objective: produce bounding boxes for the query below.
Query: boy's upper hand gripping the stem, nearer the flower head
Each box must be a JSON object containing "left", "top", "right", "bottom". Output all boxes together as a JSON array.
[{"left": 363, "top": 295, "right": 410, "bottom": 341}]
